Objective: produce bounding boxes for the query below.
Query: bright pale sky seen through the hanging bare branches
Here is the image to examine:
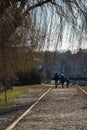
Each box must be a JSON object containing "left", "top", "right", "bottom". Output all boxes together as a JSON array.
[{"left": 28, "top": 0, "right": 87, "bottom": 52}]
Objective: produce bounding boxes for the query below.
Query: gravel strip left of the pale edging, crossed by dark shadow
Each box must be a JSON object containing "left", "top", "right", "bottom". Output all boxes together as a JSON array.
[{"left": 0, "top": 89, "right": 46, "bottom": 130}]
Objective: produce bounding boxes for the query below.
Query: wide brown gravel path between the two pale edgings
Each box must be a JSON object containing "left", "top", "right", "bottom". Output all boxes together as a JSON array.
[{"left": 14, "top": 88, "right": 87, "bottom": 130}]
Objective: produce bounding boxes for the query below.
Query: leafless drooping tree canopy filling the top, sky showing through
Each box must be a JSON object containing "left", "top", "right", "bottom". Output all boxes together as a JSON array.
[{"left": 0, "top": 0, "right": 87, "bottom": 74}]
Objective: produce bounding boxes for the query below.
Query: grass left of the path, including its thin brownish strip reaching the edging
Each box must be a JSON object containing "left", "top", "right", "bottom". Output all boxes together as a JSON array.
[{"left": 0, "top": 84, "right": 49, "bottom": 107}]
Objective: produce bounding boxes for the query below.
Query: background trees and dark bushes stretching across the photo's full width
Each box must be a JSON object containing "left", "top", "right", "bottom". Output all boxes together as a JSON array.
[{"left": 0, "top": 47, "right": 87, "bottom": 102}]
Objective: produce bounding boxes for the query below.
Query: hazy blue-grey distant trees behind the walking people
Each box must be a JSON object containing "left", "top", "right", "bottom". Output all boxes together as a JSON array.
[{"left": 43, "top": 48, "right": 87, "bottom": 76}]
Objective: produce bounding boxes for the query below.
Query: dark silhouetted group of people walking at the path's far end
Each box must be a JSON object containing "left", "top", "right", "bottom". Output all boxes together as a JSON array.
[{"left": 54, "top": 73, "right": 69, "bottom": 88}]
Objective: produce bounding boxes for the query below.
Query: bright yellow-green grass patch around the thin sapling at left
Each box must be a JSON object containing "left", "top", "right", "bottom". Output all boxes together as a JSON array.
[{"left": 0, "top": 87, "right": 29, "bottom": 107}]
